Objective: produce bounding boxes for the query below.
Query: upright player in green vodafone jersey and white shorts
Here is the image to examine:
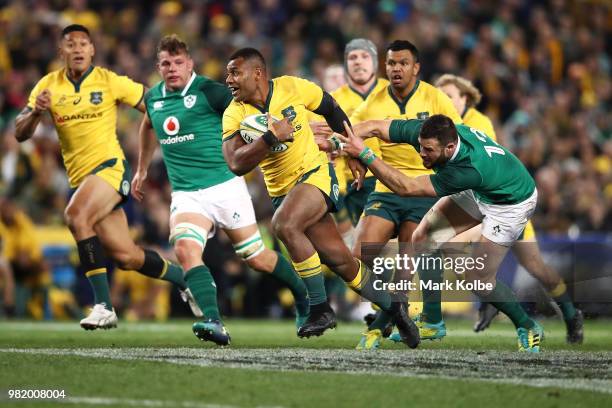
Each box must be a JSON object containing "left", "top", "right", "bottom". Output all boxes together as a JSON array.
[{"left": 133, "top": 35, "right": 308, "bottom": 345}]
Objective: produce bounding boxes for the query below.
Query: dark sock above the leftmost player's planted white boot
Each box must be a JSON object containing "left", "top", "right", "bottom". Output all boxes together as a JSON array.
[{"left": 77, "top": 235, "right": 113, "bottom": 310}]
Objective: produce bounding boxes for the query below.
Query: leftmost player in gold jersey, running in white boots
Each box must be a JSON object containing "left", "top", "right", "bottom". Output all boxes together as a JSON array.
[{"left": 15, "top": 24, "right": 195, "bottom": 330}]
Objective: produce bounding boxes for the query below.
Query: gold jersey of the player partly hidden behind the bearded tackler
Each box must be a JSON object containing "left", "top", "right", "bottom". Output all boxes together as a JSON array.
[{"left": 353, "top": 81, "right": 461, "bottom": 193}]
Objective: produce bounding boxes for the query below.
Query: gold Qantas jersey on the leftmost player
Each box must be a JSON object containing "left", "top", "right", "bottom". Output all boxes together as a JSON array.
[{"left": 28, "top": 66, "right": 144, "bottom": 188}]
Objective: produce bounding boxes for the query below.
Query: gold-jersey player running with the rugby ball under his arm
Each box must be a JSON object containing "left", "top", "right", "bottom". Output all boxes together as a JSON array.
[{"left": 223, "top": 48, "right": 419, "bottom": 347}]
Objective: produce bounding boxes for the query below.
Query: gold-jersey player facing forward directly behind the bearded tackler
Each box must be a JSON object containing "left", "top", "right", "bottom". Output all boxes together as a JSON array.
[{"left": 319, "top": 40, "right": 461, "bottom": 349}]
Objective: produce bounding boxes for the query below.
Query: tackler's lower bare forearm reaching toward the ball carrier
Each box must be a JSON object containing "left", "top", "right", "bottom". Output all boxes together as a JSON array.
[{"left": 338, "top": 123, "right": 437, "bottom": 197}]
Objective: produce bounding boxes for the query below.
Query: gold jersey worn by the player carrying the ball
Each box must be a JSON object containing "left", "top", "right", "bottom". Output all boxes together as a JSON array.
[{"left": 223, "top": 76, "right": 327, "bottom": 197}]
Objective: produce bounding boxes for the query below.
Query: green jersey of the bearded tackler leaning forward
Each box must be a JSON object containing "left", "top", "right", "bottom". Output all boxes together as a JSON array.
[{"left": 389, "top": 120, "right": 535, "bottom": 204}]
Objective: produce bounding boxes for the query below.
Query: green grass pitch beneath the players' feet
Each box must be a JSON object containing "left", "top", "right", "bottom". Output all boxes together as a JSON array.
[{"left": 0, "top": 320, "right": 612, "bottom": 408}]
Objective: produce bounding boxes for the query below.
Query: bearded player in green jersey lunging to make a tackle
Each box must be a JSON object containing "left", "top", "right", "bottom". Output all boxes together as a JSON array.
[{"left": 339, "top": 115, "right": 544, "bottom": 352}]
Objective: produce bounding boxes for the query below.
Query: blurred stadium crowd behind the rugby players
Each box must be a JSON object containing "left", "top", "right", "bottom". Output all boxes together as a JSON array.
[{"left": 0, "top": 0, "right": 612, "bottom": 317}]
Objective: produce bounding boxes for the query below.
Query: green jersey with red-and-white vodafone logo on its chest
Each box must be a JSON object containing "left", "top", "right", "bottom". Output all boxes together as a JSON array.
[{"left": 145, "top": 73, "right": 236, "bottom": 191}]
